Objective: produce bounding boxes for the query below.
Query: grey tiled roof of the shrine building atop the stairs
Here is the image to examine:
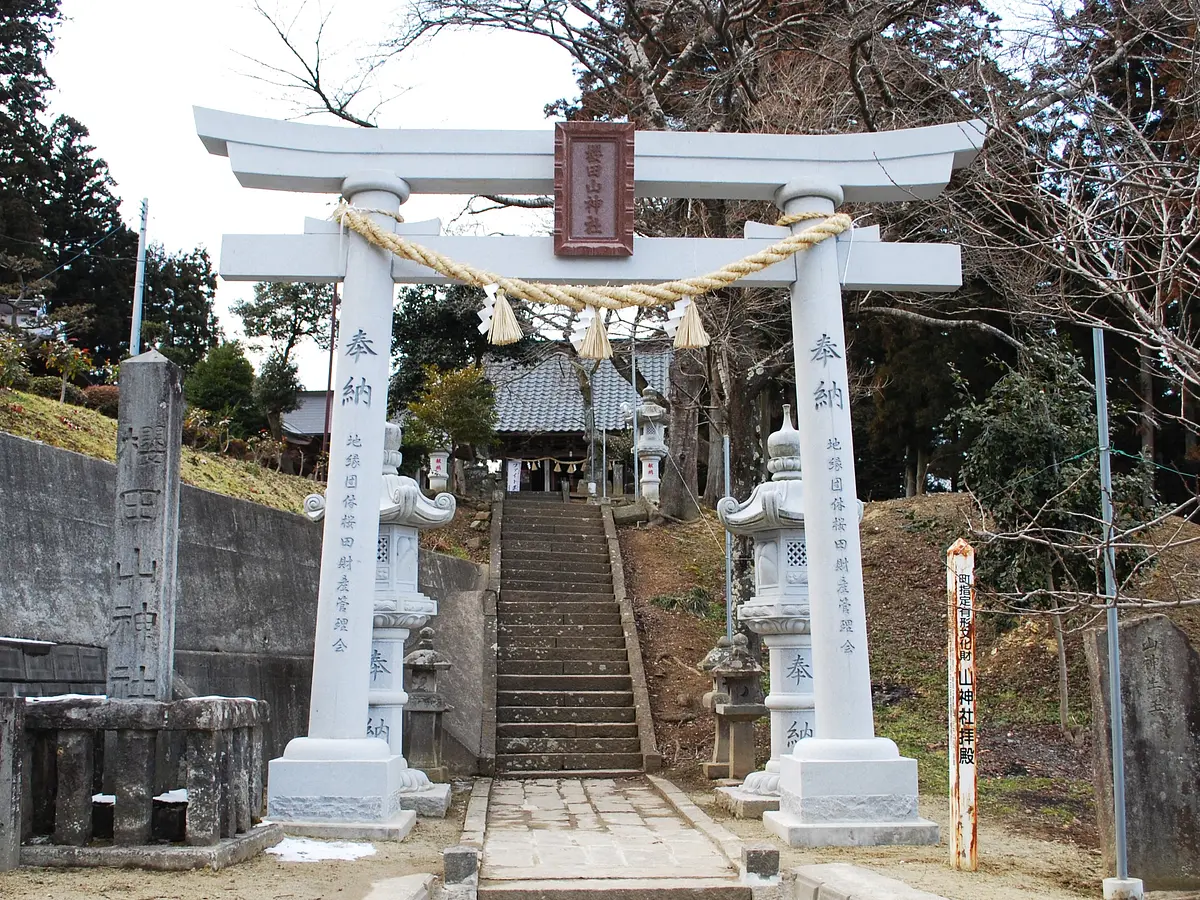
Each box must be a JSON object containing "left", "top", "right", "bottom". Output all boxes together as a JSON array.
[{"left": 484, "top": 350, "right": 671, "bottom": 433}]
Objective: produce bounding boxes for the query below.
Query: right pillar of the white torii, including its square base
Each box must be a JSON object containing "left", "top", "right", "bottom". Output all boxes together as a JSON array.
[{"left": 763, "top": 181, "right": 938, "bottom": 847}]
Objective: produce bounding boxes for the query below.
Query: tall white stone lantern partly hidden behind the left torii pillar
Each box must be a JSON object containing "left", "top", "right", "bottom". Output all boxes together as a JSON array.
[{"left": 305, "top": 422, "right": 456, "bottom": 815}]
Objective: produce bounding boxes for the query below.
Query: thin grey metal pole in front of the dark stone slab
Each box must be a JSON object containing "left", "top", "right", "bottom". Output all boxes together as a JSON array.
[{"left": 1092, "top": 328, "right": 1129, "bottom": 880}]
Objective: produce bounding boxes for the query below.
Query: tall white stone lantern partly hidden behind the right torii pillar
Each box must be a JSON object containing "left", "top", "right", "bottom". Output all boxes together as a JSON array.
[{"left": 716, "top": 406, "right": 815, "bottom": 816}]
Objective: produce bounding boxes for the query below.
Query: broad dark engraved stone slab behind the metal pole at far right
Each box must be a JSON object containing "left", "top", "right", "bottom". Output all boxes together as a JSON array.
[{"left": 1084, "top": 616, "right": 1200, "bottom": 890}]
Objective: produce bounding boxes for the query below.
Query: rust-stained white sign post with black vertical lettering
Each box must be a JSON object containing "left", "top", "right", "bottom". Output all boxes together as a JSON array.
[{"left": 946, "top": 538, "right": 979, "bottom": 872}]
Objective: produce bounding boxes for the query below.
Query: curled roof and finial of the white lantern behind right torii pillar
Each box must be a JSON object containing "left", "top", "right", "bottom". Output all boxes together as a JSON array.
[{"left": 716, "top": 406, "right": 804, "bottom": 535}]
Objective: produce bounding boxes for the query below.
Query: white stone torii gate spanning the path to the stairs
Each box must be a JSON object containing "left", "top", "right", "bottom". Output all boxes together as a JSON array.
[{"left": 196, "top": 108, "right": 985, "bottom": 844}]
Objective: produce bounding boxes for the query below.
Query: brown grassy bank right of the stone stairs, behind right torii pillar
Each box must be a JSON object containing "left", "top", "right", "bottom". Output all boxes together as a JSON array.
[{"left": 622, "top": 494, "right": 1096, "bottom": 846}]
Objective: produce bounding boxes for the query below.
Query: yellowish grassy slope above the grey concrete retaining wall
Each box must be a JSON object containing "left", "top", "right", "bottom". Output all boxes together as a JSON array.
[{"left": 0, "top": 390, "right": 318, "bottom": 512}]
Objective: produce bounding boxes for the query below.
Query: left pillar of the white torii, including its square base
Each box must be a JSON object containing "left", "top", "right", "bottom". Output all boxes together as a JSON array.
[{"left": 266, "top": 170, "right": 416, "bottom": 840}]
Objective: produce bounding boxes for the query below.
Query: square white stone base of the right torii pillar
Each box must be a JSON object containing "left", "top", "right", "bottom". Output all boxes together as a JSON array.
[{"left": 762, "top": 738, "right": 940, "bottom": 847}]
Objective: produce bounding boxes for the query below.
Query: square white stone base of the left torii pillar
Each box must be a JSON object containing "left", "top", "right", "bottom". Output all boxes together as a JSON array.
[{"left": 266, "top": 738, "right": 428, "bottom": 841}]
